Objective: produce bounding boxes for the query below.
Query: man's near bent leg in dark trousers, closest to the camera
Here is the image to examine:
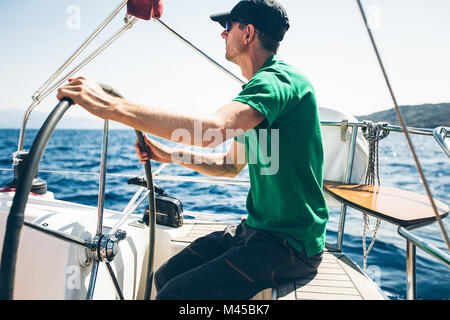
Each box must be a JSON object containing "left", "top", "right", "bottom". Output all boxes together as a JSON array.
[{"left": 156, "top": 222, "right": 321, "bottom": 300}]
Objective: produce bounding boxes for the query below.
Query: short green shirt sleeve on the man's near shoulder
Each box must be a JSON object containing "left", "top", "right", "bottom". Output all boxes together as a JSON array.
[{"left": 233, "top": 74, "right": 282, "bottom": 126}]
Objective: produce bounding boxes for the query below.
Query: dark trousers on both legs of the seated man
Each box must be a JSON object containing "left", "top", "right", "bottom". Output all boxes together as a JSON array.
[{"left": 155, "top": 221, "right": 322, "bottom": 300}]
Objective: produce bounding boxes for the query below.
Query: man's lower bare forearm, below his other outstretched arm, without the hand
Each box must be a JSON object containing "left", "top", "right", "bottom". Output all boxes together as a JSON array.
[{"left": 171, "top": 149, "right": 239, "bottom": 178}]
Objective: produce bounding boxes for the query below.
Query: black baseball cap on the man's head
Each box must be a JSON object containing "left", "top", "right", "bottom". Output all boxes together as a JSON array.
[{"left": 211, "top": 0, "right": 289, "bottom": 41}]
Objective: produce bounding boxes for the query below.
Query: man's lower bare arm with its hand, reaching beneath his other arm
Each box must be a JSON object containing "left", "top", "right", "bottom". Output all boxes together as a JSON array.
[{"left": 135, "top": 136, "right": 247, "bottom": 178}]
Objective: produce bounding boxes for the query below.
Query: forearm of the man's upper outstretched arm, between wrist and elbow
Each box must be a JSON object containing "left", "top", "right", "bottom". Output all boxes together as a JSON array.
[{"left": 108, "top": 99, "right": 221, "bottom": 147}]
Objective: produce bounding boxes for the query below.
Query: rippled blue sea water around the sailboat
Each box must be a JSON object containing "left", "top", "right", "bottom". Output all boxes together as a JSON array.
[{"left": 0, "top": 129, "right": 450, "bottom": 299}]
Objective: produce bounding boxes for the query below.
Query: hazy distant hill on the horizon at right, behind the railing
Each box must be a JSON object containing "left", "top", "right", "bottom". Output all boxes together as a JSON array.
[{"left": 357, "top": 103, "right": 450, "bottom": 128}]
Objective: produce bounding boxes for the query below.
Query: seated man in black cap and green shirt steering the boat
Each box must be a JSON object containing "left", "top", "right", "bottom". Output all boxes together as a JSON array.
[{"left": 58, "top": 0, "right": 328, "bottom": 299}]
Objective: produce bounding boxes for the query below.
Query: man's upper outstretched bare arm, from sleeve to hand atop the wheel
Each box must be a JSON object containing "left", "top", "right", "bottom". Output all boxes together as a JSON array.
[{"left": 57, "top": 77, "right": 264, "bottom": 148}]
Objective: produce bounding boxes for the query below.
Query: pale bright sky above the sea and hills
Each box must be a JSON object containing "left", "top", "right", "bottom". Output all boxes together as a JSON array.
[{"left": 0, "top": 0, "right": 450, "bottom": 127}]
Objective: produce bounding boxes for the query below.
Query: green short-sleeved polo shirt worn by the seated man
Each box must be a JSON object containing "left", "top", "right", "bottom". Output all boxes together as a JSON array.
[{"left": 234, "top": 55, "right": 329, "bottom": 257}]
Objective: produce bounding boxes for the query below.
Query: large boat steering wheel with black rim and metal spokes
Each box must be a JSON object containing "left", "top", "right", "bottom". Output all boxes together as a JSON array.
[{"left": 0, "top": 84, "right": 156, "bottom": 300}]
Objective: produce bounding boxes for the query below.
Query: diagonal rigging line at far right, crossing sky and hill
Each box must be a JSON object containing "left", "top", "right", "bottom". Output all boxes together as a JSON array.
[{"left": 356, "top": 0, "right": 450, "bottom": 251}]
